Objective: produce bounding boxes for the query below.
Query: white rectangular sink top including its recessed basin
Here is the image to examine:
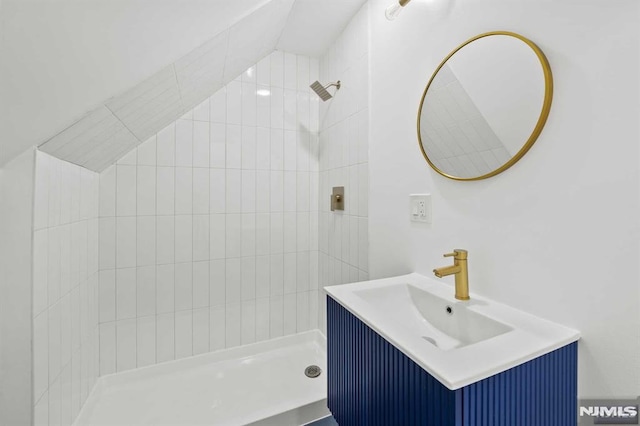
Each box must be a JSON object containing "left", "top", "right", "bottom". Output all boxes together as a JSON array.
[{"left": 325, "top": 274, "right": 580, "bottom": 390}]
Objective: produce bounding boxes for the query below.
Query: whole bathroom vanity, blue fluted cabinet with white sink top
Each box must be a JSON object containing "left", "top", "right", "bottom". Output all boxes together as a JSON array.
[{"left": 326, "top": 274, "right": 579, "bottom": 426}]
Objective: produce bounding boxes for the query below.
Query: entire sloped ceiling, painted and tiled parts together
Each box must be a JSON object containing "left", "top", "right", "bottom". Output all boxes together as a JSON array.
[{"left": 0, "top": 0, "right": 365, "bottom": 171}]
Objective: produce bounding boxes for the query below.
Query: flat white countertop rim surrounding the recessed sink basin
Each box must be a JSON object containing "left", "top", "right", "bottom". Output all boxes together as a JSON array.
[{"left": 325, "top": 273, "right": 580, "bottom": 390}]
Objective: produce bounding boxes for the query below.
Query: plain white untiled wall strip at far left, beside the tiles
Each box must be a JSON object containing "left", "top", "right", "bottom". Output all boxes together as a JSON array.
[{"left": 0, "top": 149, "right": 35, "bottom": 425}]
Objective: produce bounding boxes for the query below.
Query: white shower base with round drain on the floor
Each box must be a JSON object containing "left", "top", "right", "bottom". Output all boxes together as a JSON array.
[{"left": 74, "top": 330, "right": 329, "bottom": 426}]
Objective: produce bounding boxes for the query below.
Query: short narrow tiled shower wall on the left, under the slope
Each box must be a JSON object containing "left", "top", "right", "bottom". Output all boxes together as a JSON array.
[{"left": 33, "top": 151, "right": 99, "bottom": 425}]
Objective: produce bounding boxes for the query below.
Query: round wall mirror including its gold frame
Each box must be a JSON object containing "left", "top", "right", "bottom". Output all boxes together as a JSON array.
[{"left": 418, "top": 31, "right": 553, "bottom": 180}]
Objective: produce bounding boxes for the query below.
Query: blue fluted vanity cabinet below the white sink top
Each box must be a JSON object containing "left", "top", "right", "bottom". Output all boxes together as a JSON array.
[{"left": 327, "top": 296, "right": 577, "bottom": 426}]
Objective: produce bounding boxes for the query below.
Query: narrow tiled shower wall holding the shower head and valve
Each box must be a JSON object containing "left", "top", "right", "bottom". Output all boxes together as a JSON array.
[{"left": 319, "top": 3, "right": 369, "bottom": 331}]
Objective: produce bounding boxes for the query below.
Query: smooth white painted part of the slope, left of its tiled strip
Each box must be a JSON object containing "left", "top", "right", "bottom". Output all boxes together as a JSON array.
[{"left": 0, "top": 0, "right": 265, "bottom": 164}]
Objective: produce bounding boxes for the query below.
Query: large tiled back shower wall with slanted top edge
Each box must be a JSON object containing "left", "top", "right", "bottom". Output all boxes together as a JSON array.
[{"left": 99, "top": 52, "right": 319, "bottom": 374}]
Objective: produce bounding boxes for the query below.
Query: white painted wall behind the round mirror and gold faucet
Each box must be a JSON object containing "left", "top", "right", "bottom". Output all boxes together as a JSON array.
[{"left": 369, "top": 0, "right": 640, "bottom": 397}]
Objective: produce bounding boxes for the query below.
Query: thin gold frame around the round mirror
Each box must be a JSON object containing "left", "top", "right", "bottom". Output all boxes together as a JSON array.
[{"left": 417, "top": 31, "right": 553, "bottom": 181}]
